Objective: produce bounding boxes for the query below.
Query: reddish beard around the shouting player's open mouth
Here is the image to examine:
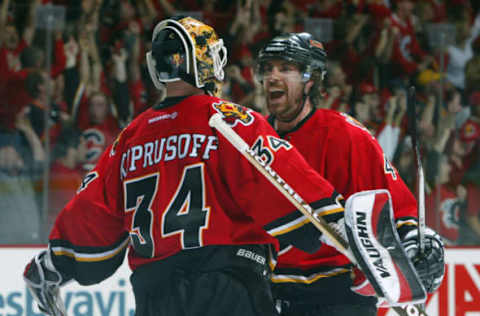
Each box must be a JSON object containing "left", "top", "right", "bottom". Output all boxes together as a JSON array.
[{"left": 267, "top": 88, "right": 302, "bottom": 122}]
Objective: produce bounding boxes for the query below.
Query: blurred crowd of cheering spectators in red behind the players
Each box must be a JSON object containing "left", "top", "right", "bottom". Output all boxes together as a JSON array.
[{"left": 0, "top": 0, "right": 480, "bottom": 245}]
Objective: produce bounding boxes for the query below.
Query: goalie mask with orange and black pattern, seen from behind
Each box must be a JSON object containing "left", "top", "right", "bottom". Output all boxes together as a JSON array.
[{"left": 147, "top": 17, "right": 227, "bottom": 96}]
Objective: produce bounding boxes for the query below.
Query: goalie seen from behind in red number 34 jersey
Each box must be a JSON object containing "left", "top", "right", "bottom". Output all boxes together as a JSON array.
[{"left": 24, "top": 17, "right": 343, "bottom": 316}]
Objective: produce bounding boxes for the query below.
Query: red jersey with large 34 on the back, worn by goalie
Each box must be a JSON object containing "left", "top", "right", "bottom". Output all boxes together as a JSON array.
[{"left": 49, "top": 95, "right": 343, "bottom": 284}]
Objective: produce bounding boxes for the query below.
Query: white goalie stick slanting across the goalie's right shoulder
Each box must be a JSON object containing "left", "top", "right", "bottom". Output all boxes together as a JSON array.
[{"left": 209, "top": 113, "right": 428, "bottom": 316}]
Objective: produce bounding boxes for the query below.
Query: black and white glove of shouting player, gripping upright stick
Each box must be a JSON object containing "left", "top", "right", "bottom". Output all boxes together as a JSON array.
[{"left": 402, "top": 227, "right": 445, "bottom": 293}]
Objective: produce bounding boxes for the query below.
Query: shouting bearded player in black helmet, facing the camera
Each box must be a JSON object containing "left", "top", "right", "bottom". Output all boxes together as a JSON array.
[{"left": 256, "top": 33, "right": 444, "bottom": 316}]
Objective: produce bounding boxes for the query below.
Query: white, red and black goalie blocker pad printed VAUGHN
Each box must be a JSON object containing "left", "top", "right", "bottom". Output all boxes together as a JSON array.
[{"left": 345, "top": 190, "right": 426, "bottom": 306}]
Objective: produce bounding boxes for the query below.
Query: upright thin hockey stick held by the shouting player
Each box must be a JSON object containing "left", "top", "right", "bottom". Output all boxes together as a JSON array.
[{"left": 407, "top": 86, "right": 425, "bottom": 255}]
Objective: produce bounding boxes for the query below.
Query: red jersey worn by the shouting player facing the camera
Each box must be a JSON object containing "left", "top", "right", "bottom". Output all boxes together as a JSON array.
[{"left": 269, "top": 109, "right": 417, "bottom": 284}]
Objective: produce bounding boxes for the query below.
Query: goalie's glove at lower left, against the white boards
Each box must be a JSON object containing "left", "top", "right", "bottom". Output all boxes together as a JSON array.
[{"left": 23, "top": 250, "right": 66, "bottom": 316}]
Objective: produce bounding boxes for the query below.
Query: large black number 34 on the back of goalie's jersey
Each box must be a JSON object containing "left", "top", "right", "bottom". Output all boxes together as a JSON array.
[{"left": 124, "top": 163, "right": 210, "bottom": 257}]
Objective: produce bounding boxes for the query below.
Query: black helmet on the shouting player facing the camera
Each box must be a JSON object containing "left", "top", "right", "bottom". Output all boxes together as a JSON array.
[{"left": 255, "top": 32, "right": 327, "bottom": 82}]
